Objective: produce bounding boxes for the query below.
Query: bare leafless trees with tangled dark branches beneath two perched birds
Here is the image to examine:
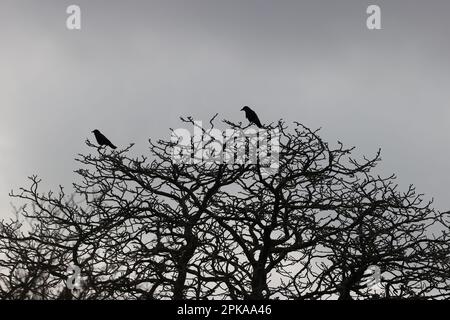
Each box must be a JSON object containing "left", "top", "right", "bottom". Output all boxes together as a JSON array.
[{"left": 0, "top": 118, "right": 450, "bottom": 299}]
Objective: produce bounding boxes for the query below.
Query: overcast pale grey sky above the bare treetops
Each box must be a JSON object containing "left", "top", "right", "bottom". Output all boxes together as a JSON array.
[{"left": 0, "top": 0, "right": 450, "bottom": 217}]
